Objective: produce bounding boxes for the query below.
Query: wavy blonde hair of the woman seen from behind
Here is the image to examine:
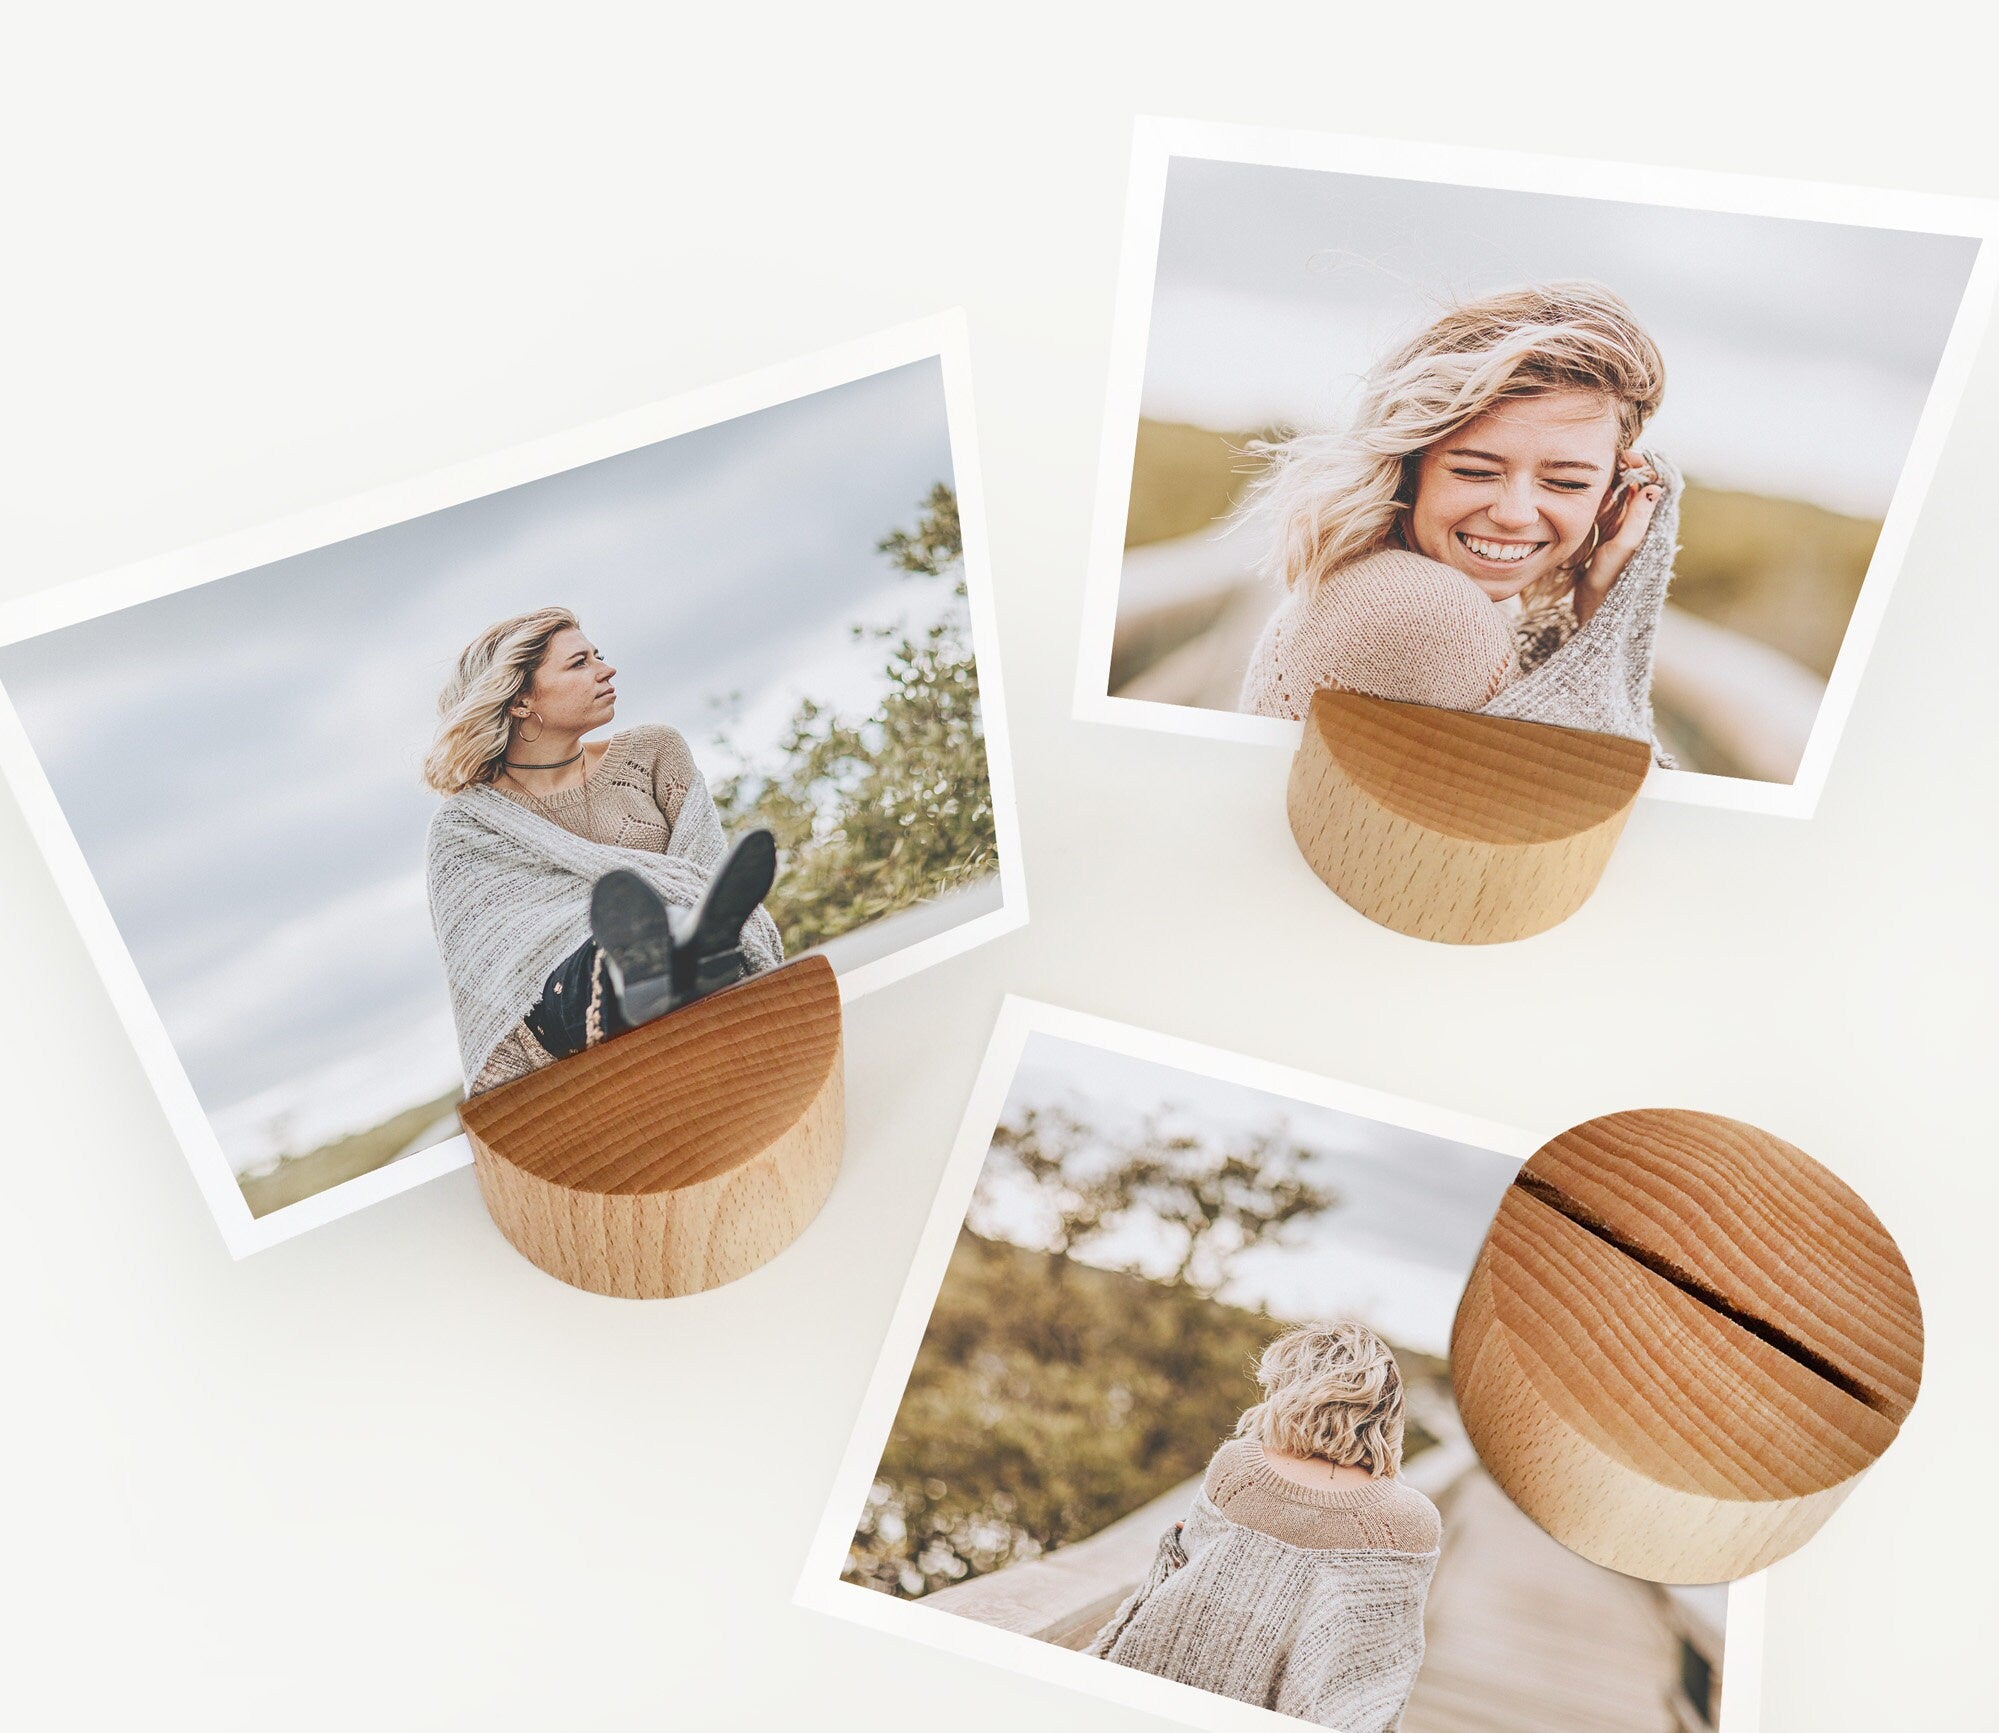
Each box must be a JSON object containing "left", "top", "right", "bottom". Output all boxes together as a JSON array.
[{"left": 1235, "top": 1319, "right": 1401, "bottom": 1475}]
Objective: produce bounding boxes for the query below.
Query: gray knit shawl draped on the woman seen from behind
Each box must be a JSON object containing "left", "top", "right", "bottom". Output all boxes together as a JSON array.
[{"left": 1089, "top": 1483, "right": 1437, "bottom": 1733}]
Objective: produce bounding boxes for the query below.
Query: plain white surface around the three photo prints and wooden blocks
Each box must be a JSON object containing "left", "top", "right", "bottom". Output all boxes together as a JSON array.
[{"left": 0, "top": 0, "right": 1999, "bottom": 1733}]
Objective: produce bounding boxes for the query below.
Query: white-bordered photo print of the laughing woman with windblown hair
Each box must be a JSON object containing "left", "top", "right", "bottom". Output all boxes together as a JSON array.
[{"left": 1077, "top": 122, "right": 1993, "bottom": 816}]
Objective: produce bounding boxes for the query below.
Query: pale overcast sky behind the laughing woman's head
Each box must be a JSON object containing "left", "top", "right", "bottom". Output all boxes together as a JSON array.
[{"left": 1143, "top": 158, "right": 1977, "bottom": 516}]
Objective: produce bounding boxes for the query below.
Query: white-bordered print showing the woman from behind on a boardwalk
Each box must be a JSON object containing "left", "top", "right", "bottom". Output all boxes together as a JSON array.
[{"left": 800, "top": 999, "right": 1761, "bottom": 1733}]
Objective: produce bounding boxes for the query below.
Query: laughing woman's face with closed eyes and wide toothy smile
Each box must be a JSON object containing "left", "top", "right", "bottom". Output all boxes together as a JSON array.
[{"left": 1409, "top": 392, "right": 1617, "bottom": 602}]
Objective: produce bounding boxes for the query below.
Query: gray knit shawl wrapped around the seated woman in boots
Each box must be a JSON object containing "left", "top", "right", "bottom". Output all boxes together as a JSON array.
[{"left": 426, "top": 727, "right": 784, "bottom": 1083}]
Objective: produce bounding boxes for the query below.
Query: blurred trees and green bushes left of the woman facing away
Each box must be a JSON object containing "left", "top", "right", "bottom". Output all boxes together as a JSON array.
[{"left": 848, "top": 1107, "right": 1359, "bottom": 1597}]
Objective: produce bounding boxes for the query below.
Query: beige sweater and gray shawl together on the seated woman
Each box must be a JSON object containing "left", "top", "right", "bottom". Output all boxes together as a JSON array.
[{"left": 426, "top": 728, "right": 784, "bottom": 1093}]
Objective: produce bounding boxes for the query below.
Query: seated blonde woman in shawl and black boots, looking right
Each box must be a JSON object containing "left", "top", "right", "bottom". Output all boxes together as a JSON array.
[{"left": 424, "top": 608, "right": 784, "bottom": 1095}]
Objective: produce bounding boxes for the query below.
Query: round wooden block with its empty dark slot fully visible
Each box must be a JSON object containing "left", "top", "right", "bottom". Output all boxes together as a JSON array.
[{"left": 1451, "top": 1109, "right": 1923, "bottom": 1583}]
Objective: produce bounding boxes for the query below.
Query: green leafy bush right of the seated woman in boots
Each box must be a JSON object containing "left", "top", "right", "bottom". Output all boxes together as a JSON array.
[{"left": 714, "top": 482, "right": 998, "bottom": 953}]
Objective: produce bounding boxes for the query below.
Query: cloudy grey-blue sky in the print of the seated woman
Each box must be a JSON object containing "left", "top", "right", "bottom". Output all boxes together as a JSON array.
[{"left": 0, "top": 362, "right": 952, "bottom": 1165}]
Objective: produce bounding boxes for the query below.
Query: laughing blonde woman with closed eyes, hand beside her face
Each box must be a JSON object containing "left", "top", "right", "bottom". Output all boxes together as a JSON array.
[{"left": 1237, "top": 282, "right": 1681, "bottom": 742}]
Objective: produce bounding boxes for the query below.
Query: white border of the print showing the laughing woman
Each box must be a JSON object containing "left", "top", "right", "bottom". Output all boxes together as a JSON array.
[{"left": 1071, "top": 116, "right": 1999, "bottom": 818}]
